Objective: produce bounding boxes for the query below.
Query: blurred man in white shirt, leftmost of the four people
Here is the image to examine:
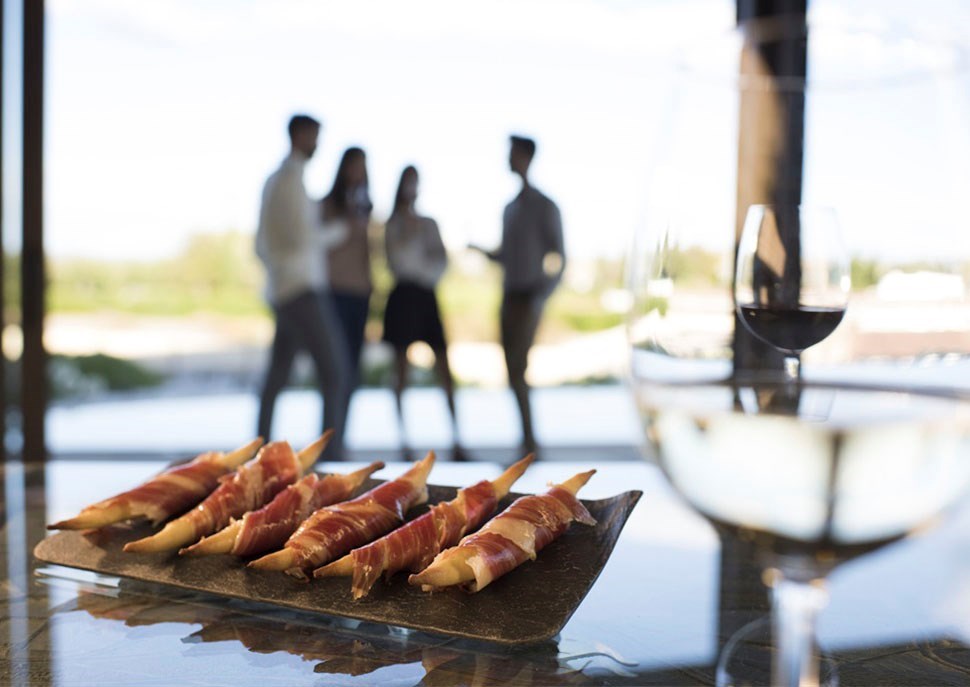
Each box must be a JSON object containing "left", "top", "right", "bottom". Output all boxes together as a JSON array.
[{"left": 256, "top": 114, "right": 349, "bottom": 460}]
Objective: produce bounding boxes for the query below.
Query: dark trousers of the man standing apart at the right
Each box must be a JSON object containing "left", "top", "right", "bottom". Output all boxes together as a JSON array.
[{"left": 499, "top": 291, "right": 546, "bottom": 451}]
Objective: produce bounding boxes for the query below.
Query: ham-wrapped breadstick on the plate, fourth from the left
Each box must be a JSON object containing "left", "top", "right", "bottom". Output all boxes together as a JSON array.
[{"left": 249, "top": 452, "right": 434, "bottom": 578}]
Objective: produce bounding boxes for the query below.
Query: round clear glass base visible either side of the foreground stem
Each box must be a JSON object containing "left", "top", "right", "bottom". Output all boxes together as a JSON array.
[{"left": 715, "top": 616, "right": 839, "bottom": 687}]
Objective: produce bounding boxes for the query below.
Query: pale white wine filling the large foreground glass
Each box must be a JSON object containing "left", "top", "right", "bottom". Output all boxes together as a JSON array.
[{"left": 636, "top": 382, "right": 970, "bottom": 557}]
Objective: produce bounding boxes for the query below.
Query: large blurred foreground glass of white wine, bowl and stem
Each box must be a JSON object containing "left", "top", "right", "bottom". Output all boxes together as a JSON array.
[{"left": 628, "top": 14, "right": 970, "bottom": 685}]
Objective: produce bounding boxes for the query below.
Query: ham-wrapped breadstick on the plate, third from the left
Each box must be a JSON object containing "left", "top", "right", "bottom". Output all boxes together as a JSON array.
[{"left": 179, "top": 461, "right": 384, "bottom": 556}]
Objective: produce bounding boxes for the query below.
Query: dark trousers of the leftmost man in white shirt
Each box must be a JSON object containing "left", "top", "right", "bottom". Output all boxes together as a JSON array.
[{"left": 258, "top": 291, "right": 349, "bottom": 460}]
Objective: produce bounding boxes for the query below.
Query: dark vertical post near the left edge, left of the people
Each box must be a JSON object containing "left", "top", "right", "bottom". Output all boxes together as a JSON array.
[{"left": 20, "top": 0, "right": 47, "bottom": 461}]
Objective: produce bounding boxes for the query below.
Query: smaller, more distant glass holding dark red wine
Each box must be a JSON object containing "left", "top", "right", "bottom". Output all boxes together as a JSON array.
[{"left": 734, "top": 205, "right": 851, "bottom": 381}]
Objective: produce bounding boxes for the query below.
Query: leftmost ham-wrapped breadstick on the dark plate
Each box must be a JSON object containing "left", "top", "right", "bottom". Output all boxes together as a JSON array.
[{"left": 47, "top": 438, "right": 263, "bottom": 530}]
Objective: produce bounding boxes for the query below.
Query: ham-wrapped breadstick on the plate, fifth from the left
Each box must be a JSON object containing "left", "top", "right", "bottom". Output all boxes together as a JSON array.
[{"left": 313, "top": 454, "right": 533, "bottom": 599}]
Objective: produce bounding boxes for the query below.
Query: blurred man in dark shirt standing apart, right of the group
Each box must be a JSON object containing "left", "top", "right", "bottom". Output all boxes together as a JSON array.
[{"left": 470, "top": 135, "right": 566, "bottom": 452}]
